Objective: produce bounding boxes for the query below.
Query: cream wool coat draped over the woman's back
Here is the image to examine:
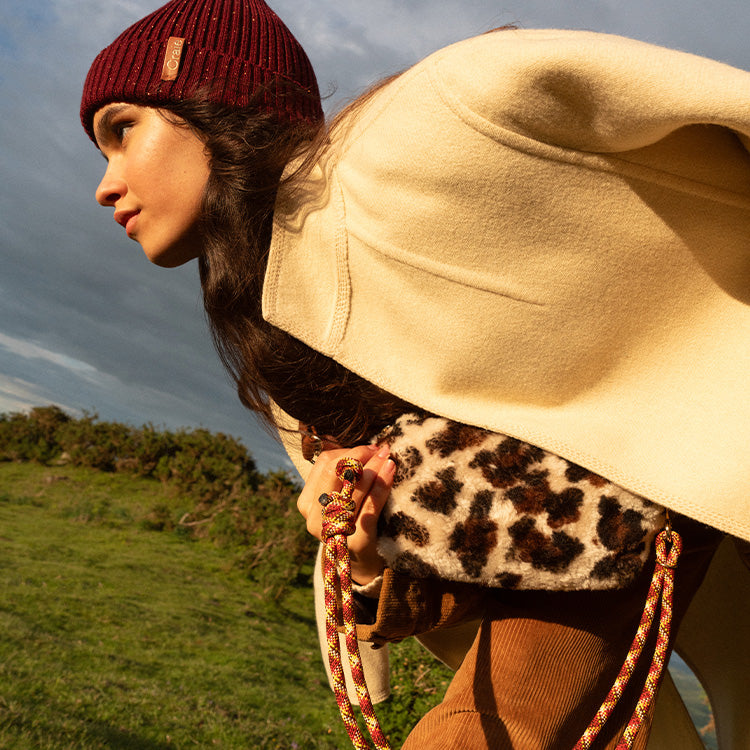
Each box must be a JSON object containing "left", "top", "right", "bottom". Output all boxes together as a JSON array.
[{"left": 263, "top": 30, "right": 750, "bottom": 747}]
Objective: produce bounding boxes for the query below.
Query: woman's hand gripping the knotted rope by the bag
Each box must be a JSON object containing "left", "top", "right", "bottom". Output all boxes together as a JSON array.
[{"left": 297, "top": 445, "right": 396, "bottom": 584}]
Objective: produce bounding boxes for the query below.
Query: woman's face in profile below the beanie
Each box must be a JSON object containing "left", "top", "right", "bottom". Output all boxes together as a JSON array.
[{"left": 94, "top": 102, "right": 209, "bottom": 268}]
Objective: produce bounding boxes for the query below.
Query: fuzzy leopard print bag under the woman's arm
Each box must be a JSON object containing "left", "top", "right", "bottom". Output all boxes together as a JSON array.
[{"left": 377, "top": 414, "right": 664, "bottom": 590}]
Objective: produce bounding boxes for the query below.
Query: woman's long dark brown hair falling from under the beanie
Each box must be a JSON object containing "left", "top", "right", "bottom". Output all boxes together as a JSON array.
[{"left": 162, "top": 79, "right": 413, "bottom": 446}]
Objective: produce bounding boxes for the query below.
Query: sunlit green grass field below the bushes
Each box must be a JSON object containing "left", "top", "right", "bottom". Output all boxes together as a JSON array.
[{"left": 0, "top": 462, "right": 712, "bottom": 750}]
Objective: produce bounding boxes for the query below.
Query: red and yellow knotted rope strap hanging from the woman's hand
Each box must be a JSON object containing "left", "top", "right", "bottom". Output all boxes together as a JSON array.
[{"left": 319, "top": 458, "right": 390, "bottom": 750}]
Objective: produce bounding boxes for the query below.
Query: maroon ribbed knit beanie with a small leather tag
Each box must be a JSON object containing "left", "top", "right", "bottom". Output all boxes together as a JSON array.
[{"left": 81, "top": 0, "right": 323, "bottom": 142}]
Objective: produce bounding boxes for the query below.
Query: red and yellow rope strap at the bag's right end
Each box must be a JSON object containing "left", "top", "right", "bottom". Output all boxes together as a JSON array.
[{"left": 574, "top": 518, "right": 682, "bottom": 750}]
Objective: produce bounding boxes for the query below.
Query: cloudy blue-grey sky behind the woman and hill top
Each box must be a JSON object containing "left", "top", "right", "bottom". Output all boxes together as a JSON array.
[{"left": 0, "top": 0, "right": 750, "bottom": 468}]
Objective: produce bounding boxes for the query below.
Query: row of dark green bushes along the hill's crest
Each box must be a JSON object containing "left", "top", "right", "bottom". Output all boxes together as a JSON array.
[{"left": 0, "top": 406, "right": 316, "bottom": 597}]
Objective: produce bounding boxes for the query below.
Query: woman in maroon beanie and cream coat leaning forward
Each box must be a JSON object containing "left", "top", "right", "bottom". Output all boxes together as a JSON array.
[{"left": 81, "top": 0, "right": 750, "bottom": 748}]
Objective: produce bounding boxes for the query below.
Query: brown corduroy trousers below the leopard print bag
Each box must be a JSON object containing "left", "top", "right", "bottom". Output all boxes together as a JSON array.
[{"left": 403, "top": 519, "right": 722, "bottom": 750}]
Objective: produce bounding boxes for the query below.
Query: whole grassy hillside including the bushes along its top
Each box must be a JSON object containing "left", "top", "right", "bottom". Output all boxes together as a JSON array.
[{"left": 0, "top": 408, "right": 716, "bottom": 750}]
